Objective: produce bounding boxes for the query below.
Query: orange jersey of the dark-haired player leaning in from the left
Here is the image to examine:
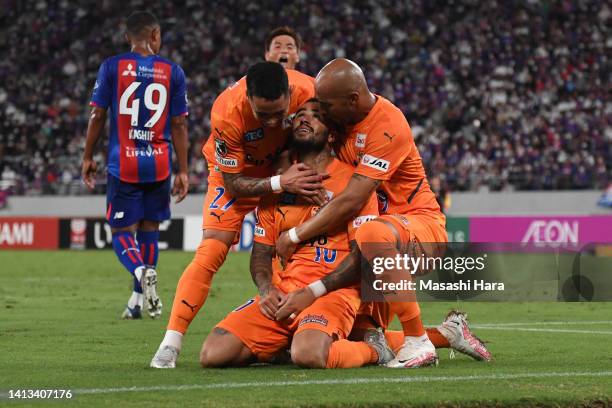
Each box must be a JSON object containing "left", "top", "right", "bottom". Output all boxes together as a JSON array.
[{"left": 202, "top": 69, "right": 314, "bottom": 177}]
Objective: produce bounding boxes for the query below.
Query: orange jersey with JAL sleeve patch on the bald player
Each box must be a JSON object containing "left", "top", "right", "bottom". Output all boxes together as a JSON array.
[{"left": 334, "top": 95, "right": 444, "bottom": 217}]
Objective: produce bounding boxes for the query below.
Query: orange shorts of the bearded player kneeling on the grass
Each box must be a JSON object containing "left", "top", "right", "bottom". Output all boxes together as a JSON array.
[{"left": 217, "top": 288, "right": 360, "bottom": 361}]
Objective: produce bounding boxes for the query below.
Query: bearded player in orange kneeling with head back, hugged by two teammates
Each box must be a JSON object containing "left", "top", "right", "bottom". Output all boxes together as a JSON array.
[{"left": 200, "top": 101, "right": 394, "bottom": 368}]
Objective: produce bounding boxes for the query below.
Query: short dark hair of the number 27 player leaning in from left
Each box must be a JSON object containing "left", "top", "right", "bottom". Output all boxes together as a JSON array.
[{"left": 247, "top": 61, "right": 289, "bottom": 101}]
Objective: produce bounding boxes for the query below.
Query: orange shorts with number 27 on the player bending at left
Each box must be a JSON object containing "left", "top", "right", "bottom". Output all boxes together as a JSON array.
[{"left": 202, "top": 170, "right": 259, "bottom": 232}]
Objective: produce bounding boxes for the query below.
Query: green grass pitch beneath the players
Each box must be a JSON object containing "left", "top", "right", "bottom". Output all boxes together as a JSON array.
[{"left": 0, "top": 250, "right": 612, "bottom": 407}]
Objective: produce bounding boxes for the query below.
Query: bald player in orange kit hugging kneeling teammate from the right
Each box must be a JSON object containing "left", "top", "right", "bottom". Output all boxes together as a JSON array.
[{"left": 276, "top": 59, "right": 490, "bottom": 368}]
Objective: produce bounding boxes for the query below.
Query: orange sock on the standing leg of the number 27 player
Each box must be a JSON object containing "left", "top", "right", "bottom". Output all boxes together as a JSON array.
[{"left": 168, "top": 239, "right": 229, "bottom": 334}]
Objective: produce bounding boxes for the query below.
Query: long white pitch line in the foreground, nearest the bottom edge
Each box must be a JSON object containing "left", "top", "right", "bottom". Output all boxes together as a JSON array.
[{"left": 56, "top": 371, "right": 612, "bottom": 395}]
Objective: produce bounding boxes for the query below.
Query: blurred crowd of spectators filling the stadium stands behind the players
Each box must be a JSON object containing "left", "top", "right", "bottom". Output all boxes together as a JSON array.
[{"left": 0, "top": 0, "right": 612, "bottom": 194}]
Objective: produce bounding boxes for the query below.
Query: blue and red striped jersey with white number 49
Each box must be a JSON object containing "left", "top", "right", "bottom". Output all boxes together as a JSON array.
[{"left": 90, "top": 52, "right": 188, "bottom": 183}]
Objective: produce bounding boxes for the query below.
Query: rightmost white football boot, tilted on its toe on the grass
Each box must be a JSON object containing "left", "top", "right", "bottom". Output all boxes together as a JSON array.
[{"left": 438, "top": 310, "right": 491, "bottom": 361}]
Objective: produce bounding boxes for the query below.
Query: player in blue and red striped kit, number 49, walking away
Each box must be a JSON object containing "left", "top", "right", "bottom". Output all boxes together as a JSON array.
[{"left": 82, "top": 11, "right": 189, "bottom": 319}]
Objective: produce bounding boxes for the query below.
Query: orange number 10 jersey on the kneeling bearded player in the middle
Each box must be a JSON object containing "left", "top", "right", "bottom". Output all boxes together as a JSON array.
[{"left": 255, "top": 159, "right": 378, "bottom": 292}]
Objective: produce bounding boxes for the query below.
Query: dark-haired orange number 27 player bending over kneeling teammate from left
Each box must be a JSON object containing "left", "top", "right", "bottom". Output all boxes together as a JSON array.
[{"left": 150, "top": 62, "right": 323, "bottom": 368}]
